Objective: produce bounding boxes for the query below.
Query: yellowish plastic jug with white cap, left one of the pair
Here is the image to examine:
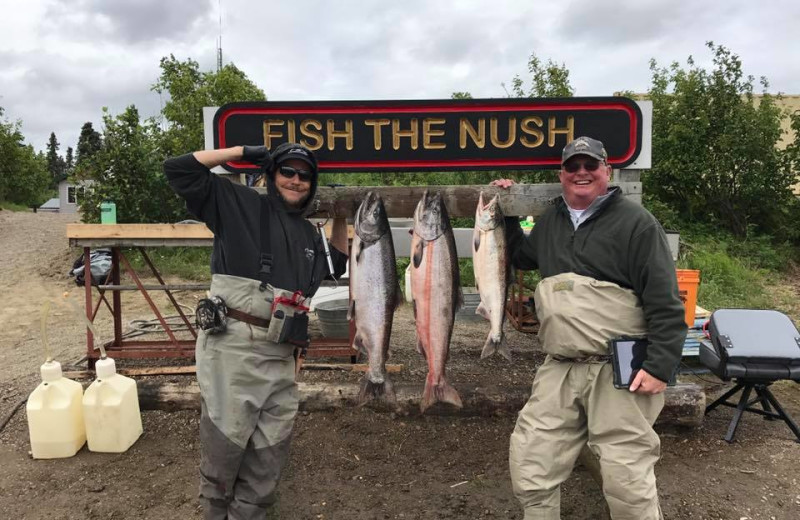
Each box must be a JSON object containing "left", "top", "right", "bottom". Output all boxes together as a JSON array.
[{"left": 25, "top": 361, "right": 86, "bottom": 459}]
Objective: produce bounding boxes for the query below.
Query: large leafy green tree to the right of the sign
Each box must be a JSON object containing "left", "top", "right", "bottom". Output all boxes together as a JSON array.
[{"left": 643, "top": 42, "right": 795, "bottom": 236}]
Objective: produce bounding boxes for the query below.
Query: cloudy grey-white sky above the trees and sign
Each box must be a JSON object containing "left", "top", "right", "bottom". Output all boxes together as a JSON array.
[{"left": 0, "top": 0, "right": 800, "bottom": 154}]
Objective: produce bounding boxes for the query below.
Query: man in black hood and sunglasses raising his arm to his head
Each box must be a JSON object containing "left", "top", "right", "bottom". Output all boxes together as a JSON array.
[{"left": 164, "top": 143, "right": 347, "bottom": 520}]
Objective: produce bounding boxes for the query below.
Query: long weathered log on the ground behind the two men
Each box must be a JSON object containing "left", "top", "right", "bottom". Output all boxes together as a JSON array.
[{"left": 137, "top": 380, "right": 706, "bottom": 426}]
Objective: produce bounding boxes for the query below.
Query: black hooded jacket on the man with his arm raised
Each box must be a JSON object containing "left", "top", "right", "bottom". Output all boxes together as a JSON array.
[{"left": 164, "top": 154, "right": 347, "bottom": 296}]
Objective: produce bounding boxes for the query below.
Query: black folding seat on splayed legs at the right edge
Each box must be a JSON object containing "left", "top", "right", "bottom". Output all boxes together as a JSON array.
[{"left": 700, "top": 309, "right": 800, "bottom": 442}]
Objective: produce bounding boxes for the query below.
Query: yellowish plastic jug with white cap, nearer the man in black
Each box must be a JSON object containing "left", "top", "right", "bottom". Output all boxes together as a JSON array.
[{"left": 83, "top": 358, "right": 142, "bottom": 453}]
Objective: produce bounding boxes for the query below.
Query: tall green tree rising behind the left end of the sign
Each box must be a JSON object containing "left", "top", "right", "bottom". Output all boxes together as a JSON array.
[{"left": 152, "top": 54, "right": 266, "bottom": 156}]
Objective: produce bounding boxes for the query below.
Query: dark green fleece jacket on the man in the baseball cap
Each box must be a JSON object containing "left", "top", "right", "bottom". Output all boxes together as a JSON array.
[{"left": 506, "top": 188, "right": 686, "bottom": 381}]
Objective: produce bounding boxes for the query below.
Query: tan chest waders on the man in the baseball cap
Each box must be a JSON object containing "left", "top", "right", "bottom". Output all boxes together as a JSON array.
[{"left": 509, "top": 273, "right": 664, "bottom": 520}]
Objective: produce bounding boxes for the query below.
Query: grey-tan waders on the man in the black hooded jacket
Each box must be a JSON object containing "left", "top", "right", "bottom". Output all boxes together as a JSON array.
[{"left": 196, "top": 275, "right": 298, "bottom": 520}]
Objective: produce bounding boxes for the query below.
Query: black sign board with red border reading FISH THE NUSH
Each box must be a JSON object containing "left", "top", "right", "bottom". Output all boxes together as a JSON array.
[{"left": 213, "top": 97, "right": 642, "bottom": 172}]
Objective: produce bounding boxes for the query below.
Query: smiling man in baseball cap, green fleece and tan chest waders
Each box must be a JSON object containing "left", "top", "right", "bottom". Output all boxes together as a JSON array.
[{"left": 493, "top": 137, "right": 686, "bottom": 520}]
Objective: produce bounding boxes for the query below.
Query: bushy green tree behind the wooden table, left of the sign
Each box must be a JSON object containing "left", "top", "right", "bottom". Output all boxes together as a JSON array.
[{"left": 77, "top": 105, "right": 187, "bottom": 223}]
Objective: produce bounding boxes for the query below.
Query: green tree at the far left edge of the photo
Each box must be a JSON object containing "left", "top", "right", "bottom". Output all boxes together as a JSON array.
[{"left": 0, "top": 107, "right": 51, "bottom": 206}]
